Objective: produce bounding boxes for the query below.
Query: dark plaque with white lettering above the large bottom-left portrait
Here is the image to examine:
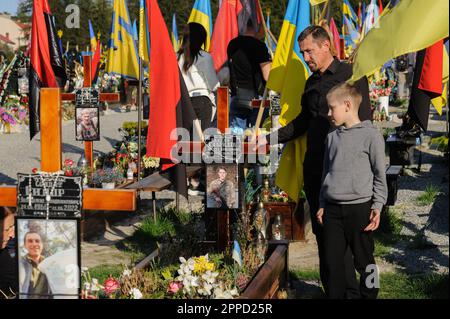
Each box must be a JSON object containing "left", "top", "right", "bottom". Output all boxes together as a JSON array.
[{"left": 17, "top": 174, "right": 83, "bottom": 218}]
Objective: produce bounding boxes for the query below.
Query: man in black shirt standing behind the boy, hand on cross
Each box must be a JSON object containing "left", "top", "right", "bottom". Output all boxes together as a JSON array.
[{"left": 259, "top": 26, "right": 372, "bottom": 298}]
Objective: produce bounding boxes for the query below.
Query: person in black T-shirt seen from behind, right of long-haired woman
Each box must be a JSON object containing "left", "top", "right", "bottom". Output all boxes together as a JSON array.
[{"left": 227, "top": 19, "right": 272, "bottom": 130}]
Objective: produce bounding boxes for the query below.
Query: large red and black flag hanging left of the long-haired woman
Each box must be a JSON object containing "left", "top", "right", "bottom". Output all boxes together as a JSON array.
[{"left": 146, "top": 0, "right": 196, "bottom": 197}]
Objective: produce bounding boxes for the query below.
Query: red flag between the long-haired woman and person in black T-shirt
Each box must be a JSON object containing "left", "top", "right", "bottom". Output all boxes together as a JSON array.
[{"left": 211, "top": 0, "right": 242, "bottom": 72}]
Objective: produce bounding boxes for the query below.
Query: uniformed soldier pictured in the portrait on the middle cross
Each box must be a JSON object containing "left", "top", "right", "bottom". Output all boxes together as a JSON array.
[{"left": 207, "top": 166, "right": 238, "bottom": 209}]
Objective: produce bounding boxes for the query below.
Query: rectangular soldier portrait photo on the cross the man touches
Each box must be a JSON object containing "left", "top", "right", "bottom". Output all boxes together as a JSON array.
[{"left": 206, "top": 164, "right": 240, "bottom": 209}]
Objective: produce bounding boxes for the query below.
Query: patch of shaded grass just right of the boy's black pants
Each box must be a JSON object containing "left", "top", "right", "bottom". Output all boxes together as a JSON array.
[{"left": 374, "top": 207, "right": 408, "bottom": 257}]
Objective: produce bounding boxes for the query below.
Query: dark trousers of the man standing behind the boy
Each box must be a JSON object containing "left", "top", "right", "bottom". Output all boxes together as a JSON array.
[{"left": 303, "top": 172, "right": 360, "bottom": 299}]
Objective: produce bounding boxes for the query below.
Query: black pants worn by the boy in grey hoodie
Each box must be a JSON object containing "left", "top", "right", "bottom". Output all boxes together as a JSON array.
[{"left": 323, "top": 202, "right": 378, "bottom": 299}]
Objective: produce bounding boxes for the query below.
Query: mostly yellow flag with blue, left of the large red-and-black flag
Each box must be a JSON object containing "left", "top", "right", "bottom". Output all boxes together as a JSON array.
[{"left": 106, "top": 0, "right": 139, "bottom": 79}]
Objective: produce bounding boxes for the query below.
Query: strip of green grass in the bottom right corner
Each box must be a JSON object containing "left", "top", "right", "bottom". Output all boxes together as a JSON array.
[{"left": 378, "top": 272, "right": 449, "bottom": 299}]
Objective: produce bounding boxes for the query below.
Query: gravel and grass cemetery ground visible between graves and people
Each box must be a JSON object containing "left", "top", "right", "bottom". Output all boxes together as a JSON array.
[{"left": 0, "top": 104, "right": 449, "bottom": 299}]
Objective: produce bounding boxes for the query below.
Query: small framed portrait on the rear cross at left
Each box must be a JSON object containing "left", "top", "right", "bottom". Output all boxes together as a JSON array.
[{"left": 75, "top": 107, "right": 100, "bottom": 141}]
